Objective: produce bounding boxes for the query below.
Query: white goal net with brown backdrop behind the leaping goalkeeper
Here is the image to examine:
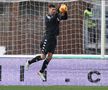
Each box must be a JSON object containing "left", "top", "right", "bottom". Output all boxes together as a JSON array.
[{"left": 0, "top": 0, "right": 105, "bottom": 55}]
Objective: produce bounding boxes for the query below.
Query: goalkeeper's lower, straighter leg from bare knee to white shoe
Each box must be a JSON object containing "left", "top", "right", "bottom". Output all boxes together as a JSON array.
[{"left": 38, "top": 53, "right": 53, "bottom": 81}]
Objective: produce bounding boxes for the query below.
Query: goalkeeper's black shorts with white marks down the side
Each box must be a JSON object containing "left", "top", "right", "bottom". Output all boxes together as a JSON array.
[{"left": 40, "top": 36, "right": 57, "bottom": 54}]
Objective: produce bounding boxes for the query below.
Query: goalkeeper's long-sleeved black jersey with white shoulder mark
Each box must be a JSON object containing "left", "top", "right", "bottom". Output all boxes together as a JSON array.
[{"left": 45, "top": 12, "right": 67, "bottom": 38}]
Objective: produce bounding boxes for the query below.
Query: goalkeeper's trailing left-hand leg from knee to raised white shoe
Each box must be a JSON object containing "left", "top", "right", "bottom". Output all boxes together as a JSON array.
[{"left": 25, "top": 54, "right": 46, "bottom": 70}]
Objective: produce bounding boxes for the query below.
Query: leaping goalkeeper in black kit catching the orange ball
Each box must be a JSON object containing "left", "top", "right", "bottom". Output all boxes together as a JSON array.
[{"left": 25, "top": 4, "right": 68, "bottom": 81}]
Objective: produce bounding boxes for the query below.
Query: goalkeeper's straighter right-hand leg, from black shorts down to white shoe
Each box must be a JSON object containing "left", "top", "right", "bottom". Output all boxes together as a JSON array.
[{"left": 38, "top": 37, "right": 57, "bottom": 81}]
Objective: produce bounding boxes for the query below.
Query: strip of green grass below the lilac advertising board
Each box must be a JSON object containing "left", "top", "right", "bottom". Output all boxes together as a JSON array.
[{"left": 0, "top": 86, "right": 108, "bottom": 90}]
